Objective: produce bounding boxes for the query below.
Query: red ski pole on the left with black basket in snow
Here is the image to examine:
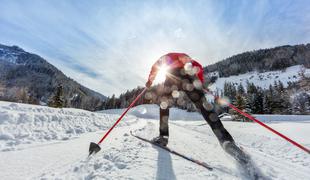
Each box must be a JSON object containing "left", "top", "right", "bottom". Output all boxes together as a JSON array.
[{"left": 89, "top": 88, "right": 147, "bottom": 155}]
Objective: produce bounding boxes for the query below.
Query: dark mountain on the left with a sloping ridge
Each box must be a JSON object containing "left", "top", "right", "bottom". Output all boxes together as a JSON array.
[{"left": 0, "top": 44, "right": 106, "bottom": 110}]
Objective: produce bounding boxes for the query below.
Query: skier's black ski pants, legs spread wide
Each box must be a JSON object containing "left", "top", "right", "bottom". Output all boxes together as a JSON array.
[{"left": 158, "top": 70, "right": 234, "bottom": 145}]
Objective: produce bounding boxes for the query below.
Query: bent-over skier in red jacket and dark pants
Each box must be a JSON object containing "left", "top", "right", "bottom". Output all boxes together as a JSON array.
[{"left": 146, "top": 53, "right": 248, "bottom": 163}]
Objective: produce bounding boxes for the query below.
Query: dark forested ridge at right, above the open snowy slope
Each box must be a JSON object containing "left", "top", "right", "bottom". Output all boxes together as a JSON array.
[{"left": 204, "top": 44, "right": 310, "bottom": 77}]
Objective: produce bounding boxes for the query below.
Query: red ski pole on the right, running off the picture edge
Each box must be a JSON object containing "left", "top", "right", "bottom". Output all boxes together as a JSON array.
[{"left": 203, "top": 89, "right": 310, "bottom": 154}]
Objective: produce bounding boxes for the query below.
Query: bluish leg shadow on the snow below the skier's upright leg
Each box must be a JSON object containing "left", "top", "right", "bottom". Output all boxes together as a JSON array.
[{"left": 156, "top": 148, "right": 176, "bottom": 180}]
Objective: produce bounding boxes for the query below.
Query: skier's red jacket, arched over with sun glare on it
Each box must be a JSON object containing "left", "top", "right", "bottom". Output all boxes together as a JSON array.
[{"left": 148, "top": 53, "right": 204, "bottom": 83}]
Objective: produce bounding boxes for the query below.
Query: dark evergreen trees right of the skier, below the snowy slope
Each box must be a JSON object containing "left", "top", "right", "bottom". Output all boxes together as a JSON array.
[{"left": 221, "top": 81, "right": 310, "bottom": 114}]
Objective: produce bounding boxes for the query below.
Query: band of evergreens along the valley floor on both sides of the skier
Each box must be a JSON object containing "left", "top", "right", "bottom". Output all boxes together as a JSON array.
[{"left": 103, "top": 81, "right": 310, "bottom": 116}]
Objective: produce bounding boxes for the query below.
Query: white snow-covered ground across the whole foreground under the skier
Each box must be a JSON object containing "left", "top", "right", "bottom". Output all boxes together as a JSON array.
[{"left": 0, "top": 102, "right": 310, "bottom": 180}]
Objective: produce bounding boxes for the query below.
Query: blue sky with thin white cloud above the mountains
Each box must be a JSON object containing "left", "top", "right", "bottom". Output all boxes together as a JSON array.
[{"left": 0, "top": 0, "right": 310, "bottom": 96}]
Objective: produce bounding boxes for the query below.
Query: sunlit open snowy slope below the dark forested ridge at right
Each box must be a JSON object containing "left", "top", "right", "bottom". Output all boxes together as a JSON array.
[{"left": 209, "top": 65, "right": 310, "bottom": 92}]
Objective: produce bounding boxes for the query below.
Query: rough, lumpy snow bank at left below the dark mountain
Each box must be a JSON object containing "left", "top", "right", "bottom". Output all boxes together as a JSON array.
[{"left": 0, "top": 101, "right": 128, "bottom": 151}]
